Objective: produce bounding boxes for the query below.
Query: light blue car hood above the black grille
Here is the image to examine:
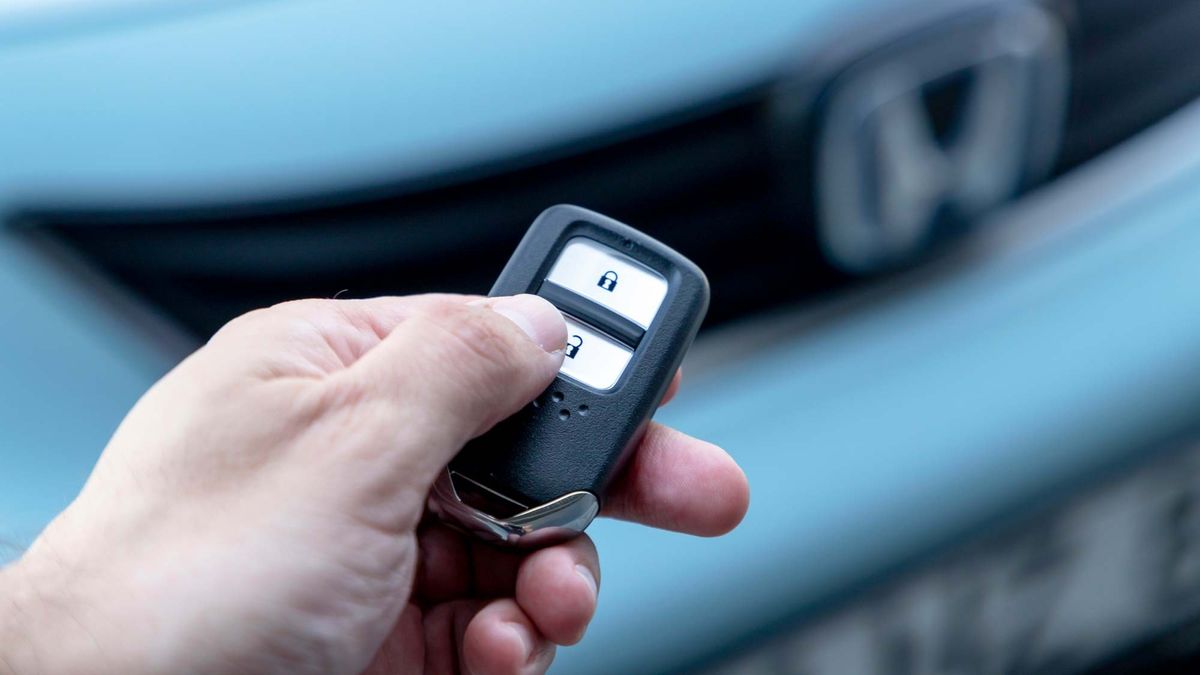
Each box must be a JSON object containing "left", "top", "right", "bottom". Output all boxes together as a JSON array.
[{"left": 0, "top": 0, "right": 883, "bottom": 207}]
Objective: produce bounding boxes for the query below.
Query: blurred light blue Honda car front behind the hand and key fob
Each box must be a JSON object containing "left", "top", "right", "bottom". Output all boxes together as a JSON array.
[{"left": 0, "top": 0, "right": 1200, "bottom": 675}]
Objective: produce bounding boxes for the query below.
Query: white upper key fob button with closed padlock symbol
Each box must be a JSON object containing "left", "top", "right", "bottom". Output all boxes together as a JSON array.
[{"left": 546, "top": 237, "right": 667, "bottom": 328}]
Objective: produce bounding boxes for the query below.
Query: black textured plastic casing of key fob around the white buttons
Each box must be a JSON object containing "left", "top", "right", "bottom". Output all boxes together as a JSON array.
[{"left": 451, "top": 205, "right": 708, "bottom": 506}]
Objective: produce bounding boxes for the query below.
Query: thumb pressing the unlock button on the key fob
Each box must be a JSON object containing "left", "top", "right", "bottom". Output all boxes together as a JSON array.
[{"left": 352, "top": 295, "right": 566, "bottom": 480}]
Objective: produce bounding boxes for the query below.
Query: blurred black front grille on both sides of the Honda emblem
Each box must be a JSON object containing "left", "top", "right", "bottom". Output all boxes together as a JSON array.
[{"left": 24, "top": 0, "right": 1200, "bottom": 336}]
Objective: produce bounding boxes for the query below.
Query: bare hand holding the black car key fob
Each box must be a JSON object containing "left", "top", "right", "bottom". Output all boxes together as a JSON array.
[{"left": 0, "top": 295, "right": 749, "bottom": 675}]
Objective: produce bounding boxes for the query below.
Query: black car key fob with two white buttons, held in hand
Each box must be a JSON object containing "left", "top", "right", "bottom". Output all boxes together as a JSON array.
[{"left": 430, "top": 205, "right": 708, "bottom": 545}]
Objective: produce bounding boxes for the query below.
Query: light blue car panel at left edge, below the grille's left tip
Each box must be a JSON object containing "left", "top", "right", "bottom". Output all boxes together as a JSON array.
[{"left": 0, "top": 236, "right": 187, "bottom": 540}]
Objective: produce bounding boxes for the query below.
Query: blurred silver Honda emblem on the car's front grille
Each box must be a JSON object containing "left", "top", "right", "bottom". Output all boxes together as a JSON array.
[{"left": 814, "top": 2, "right": 1066, "bottom": 273}]
